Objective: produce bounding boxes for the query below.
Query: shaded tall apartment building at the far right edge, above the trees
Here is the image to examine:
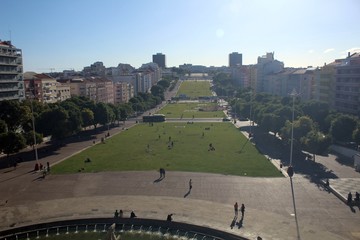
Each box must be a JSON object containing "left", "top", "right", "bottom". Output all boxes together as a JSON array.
[{"left": 334, "top": 53, "right": 360, "bottom": 116}]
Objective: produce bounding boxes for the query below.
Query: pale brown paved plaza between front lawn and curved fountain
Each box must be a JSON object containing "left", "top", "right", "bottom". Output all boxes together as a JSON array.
[{"left": 0, "top": 122, "right": 360, "bottom": 239}]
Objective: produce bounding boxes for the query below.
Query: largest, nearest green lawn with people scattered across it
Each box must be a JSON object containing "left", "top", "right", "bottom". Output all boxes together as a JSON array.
[{"left": 51, "top": 123, "right": 281, "bottom": 177}]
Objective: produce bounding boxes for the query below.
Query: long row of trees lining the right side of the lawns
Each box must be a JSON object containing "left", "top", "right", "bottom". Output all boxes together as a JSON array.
[{"left": 214, "top": 73, "right": 360, "bottom": 154}]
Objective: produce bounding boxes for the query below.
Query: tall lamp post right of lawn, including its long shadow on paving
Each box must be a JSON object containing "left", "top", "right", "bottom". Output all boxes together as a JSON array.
[{"left": 287, "top": 89, "right": 300, "bottom": 240}]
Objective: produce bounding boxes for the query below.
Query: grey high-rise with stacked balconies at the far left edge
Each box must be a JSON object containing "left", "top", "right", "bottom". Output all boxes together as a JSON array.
[{"left": 0, "top": 40, "right": 25, "bottom": 101}]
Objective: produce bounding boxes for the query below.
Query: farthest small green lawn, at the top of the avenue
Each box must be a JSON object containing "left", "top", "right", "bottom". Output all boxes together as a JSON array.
[{"left": 176, "top": 81, "right": 212, "bottom": 99}]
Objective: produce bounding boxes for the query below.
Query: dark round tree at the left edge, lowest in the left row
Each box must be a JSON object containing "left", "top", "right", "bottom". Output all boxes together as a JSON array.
[{"left": 0, "top": 131, "right": 26, "bottom": 156}]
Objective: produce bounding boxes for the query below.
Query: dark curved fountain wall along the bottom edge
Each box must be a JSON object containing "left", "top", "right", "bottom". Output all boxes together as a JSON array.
[{"left": 0, "top": 218, "right": 246, "bottom": 240}]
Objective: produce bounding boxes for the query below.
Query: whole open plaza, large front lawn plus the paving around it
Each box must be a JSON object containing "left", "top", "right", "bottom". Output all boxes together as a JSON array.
[{"left": 0, "top": 81, "right": 360, "bottom": 240}]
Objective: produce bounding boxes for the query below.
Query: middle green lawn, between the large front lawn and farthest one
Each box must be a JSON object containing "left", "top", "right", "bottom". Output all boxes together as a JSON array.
[{"left": 158, "top": 102, "right": 225, "bottom": 118}]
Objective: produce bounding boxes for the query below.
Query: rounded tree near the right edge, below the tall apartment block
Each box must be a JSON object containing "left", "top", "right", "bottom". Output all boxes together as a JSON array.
[{"left": 330, "top": 115, "right": 358, "bottom": 142}]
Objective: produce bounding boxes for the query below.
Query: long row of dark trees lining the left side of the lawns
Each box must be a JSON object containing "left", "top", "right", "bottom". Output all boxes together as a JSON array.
[{"left": 0, "top": 79, "right": 171, "bottom": 158}]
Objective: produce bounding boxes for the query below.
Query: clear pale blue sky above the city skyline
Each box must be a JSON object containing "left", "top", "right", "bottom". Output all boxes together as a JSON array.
[{"left": 0, "top": 0, "right": 360, "bottom": 72}]
